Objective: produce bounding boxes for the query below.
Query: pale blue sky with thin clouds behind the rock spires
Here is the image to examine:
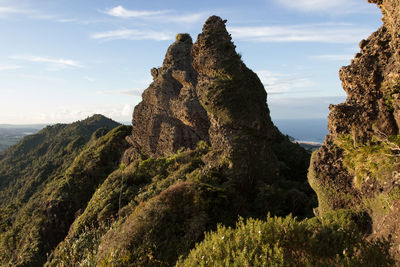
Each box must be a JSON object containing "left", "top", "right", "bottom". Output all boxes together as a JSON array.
[{"left": 0, "top": 0, "right": 382, "bottom": 124}]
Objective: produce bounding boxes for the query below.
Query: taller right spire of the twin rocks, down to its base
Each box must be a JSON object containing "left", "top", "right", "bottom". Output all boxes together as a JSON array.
[{"left": 192, "top": 16, "right": 278, "bottom": 189}]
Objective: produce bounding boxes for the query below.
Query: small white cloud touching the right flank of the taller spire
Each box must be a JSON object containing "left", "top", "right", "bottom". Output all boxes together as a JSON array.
[{"left": 256, "top": 70, "right": 314, "bottom": 94}]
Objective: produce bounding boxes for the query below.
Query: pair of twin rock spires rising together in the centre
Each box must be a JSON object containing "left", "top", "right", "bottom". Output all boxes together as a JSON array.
[{"left": 124, "top": 16, "right": 280, "bottom": 193}]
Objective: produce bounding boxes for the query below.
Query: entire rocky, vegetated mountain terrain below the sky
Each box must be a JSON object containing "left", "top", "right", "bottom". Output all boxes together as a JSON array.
[{"left": 0, "top": 0, "right": 400, "bottom": 266}]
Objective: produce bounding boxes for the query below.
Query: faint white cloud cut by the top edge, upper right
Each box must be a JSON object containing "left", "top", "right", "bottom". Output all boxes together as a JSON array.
[{"left": 275, "top": 0, "right": 377, "bottom": 14}]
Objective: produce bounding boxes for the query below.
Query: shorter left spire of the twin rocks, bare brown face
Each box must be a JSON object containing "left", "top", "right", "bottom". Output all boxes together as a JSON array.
[{"left": 125, "top": 34, "right": 209, "bottom": 162}]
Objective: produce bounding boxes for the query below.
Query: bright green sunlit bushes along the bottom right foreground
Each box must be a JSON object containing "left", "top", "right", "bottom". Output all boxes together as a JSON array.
[{"left": 176, "top": 213, "right": 394, "bottom": 266}]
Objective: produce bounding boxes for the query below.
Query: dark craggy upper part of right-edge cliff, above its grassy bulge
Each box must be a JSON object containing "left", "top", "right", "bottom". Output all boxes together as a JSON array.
[{"left": 329, "top": 0, "right": 400, "bottom": 141}]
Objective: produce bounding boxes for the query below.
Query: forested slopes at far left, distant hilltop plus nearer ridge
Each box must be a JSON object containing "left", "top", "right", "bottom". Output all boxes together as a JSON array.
[{"left": 0, "top": 115, "right": 131, "bottom": 266}]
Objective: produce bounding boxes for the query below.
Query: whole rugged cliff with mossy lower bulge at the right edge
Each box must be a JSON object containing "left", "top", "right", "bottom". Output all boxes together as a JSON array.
[{"left": 309, "top": 0, "right": 400, "bottom": 260}]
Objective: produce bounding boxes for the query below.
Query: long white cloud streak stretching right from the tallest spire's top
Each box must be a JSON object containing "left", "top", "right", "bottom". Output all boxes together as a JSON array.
[{"left": 228, "top": 24, "right": 373, "bottom": 43}]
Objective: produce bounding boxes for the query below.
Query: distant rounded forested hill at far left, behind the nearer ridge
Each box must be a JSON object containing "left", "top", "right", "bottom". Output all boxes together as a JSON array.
[{"left": 0, "top": 115, "right": 119, "bottom": 206}]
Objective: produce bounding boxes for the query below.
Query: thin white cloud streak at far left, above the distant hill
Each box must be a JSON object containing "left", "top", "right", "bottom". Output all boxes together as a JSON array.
[{"left": 10, "top": 55, "right": 83, "bottom": 70}]
